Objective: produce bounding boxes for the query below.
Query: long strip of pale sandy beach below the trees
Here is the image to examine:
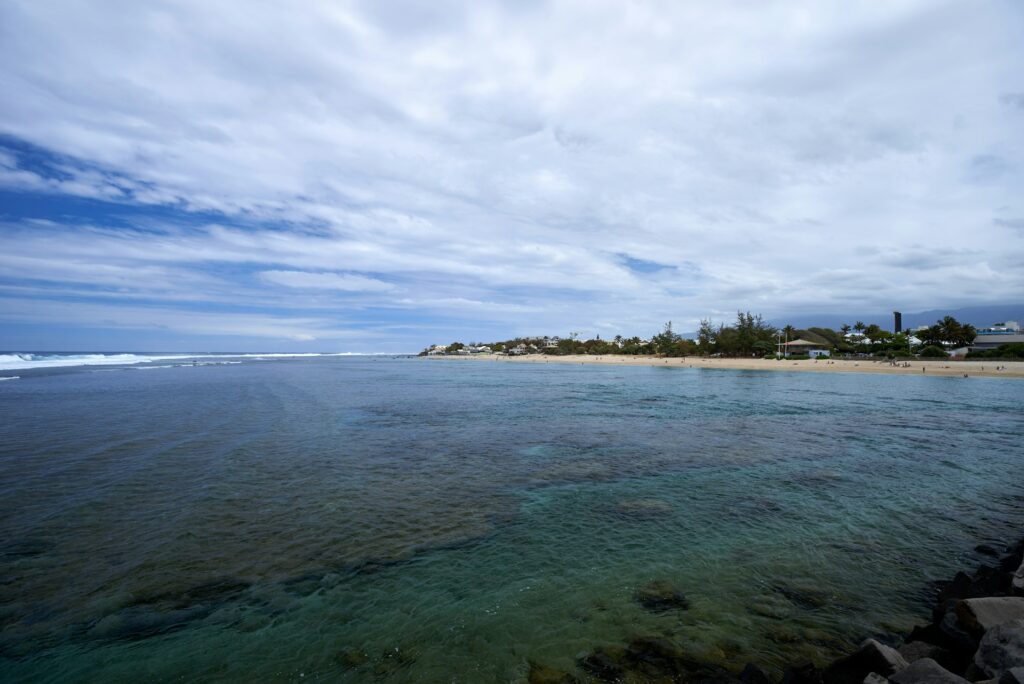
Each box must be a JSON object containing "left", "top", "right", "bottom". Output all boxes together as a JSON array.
[{"left": 428, "top": 354, "right": 1024, "bottom": 378}]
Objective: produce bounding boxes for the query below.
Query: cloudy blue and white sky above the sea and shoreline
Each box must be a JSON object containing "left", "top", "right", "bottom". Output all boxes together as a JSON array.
[{"left": 0, "top": 0, "right": 1024, "bottom": 352}]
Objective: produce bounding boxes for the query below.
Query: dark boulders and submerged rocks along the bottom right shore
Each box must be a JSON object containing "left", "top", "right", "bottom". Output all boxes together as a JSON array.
[{"left": 528, "top": 541, "right": 1024, "bottom": 684}]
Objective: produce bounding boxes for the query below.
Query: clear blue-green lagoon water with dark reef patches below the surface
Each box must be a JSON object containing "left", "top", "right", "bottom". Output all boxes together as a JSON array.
[{"left": 0, "top": 357, "right": 1024, "bottom": 682}]
